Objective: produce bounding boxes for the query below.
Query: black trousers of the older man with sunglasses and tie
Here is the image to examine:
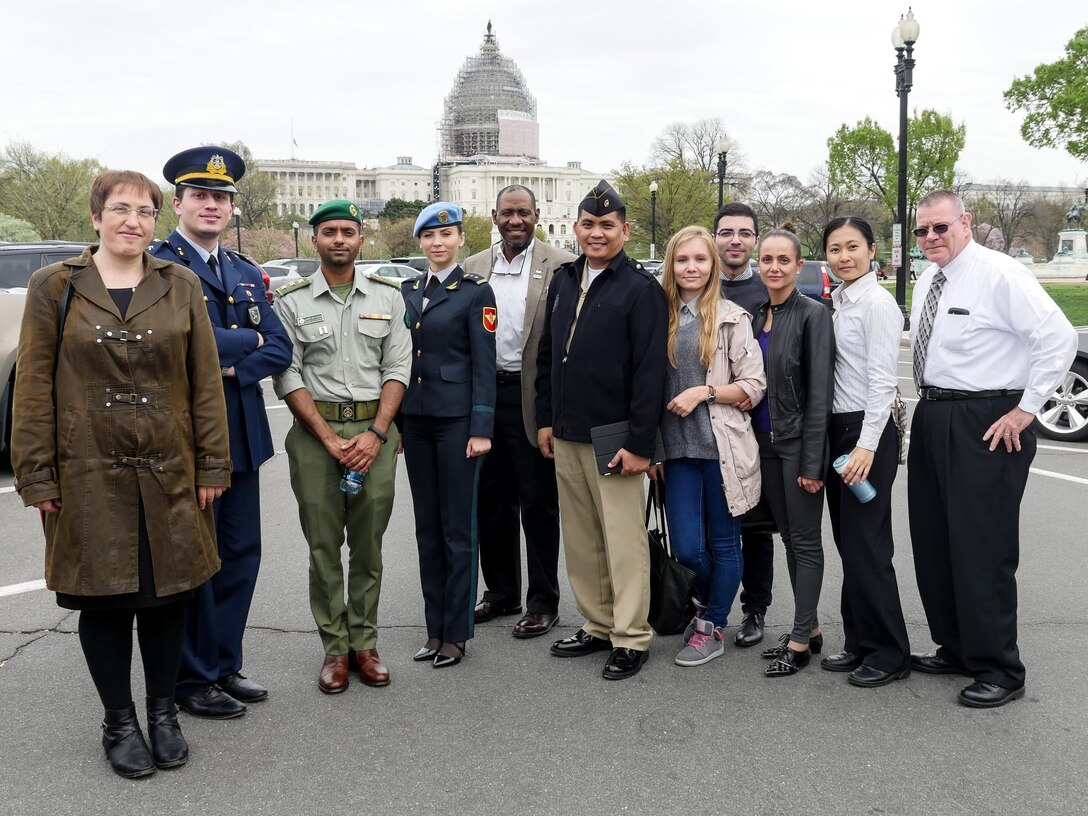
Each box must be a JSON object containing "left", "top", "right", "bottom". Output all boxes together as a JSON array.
[{"left": 906, "top": 396, "right": 1036, "bottom": 689}]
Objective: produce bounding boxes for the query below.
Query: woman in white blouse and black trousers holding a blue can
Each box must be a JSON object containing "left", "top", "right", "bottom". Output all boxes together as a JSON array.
[{"left": 821, "top": 217, "right": 911, "bottom": 688}]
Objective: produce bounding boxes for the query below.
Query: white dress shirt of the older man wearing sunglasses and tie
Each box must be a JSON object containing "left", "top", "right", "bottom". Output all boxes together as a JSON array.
[{"left": 911, "top": 240, "right": 1077, "bottom": 413}]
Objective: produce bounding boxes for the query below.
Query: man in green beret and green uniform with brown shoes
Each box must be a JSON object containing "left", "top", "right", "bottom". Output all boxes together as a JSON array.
[{"left": 274, "top": 200, "right": 411, "bottom": 694}]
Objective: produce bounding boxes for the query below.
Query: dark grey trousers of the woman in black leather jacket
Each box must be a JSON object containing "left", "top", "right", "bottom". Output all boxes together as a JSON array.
[{"left": 755, "top": 433, "right": 824, "bottom": 643}]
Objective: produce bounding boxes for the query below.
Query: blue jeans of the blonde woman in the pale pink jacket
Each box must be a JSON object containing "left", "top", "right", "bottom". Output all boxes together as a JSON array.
[{"left": 665, "top": 459, "right": 743, "bottom": 627}]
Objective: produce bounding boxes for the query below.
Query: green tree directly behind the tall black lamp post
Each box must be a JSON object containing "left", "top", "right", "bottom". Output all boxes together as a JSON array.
[{"left": 827, "top": 110, "right": 966, "bottom": 223}]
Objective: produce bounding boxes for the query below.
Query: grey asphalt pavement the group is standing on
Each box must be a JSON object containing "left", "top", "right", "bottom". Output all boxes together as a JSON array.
[{"left": 0, "top": 350, "right": 1088, "bottom": 816}]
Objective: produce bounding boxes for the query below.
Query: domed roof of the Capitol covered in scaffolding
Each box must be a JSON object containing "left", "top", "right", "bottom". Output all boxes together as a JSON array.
[{"left": 440, "top": 21, "right": 540, "bottom": 161}]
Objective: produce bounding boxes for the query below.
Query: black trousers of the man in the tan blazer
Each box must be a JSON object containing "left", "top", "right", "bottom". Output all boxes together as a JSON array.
[{"left": 477, "top": 378, "right": 559, "bottom": 615}]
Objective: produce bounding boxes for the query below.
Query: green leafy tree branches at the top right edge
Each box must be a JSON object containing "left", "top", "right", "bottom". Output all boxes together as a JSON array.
[{"left": 1004, "top": 28, "right": 1088, "bottom": 161}]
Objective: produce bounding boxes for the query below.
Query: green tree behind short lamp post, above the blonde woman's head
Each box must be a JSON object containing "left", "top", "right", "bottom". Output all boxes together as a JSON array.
[{"left": 613, "top": 158, "right": 718, "bottom": 258}]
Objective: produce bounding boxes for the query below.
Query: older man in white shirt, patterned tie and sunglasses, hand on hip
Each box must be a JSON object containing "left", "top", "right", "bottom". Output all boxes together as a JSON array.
[{"left": 907, "top": 190, "right": 1077, "bottom": 708}]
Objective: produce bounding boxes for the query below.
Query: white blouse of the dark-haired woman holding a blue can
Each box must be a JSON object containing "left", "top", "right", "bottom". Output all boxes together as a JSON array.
[{"left": 831, "top": 272, "right": 903, "bottom": 450}]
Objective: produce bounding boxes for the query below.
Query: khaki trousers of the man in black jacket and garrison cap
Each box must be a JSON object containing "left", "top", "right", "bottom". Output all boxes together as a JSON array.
[{"left": 555, "top": 440, "right": 653, "bottom": 652}]
